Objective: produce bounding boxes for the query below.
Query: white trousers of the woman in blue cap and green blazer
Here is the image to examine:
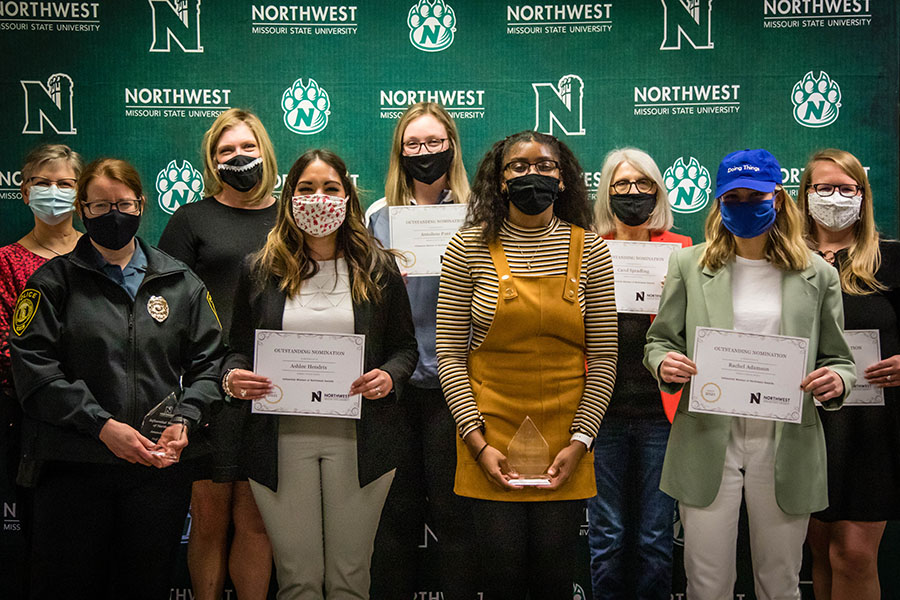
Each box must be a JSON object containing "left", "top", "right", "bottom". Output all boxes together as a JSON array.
[{"left": 679, "top": 417, "right": 809, "bottom": 600}]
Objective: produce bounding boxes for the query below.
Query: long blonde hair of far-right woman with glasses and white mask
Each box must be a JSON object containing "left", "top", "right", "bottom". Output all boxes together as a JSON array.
[{"left": 797, "top": 148, "right": 884, "bottom": 296}]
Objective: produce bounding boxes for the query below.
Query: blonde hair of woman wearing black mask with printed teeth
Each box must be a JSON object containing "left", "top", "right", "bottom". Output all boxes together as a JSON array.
[{"left": 203, "top": 108, "right": 278, "bottom": 204}]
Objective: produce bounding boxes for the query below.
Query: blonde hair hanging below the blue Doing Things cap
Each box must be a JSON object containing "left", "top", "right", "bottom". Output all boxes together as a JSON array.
[{"left": 700, "top": 186, "right": 810, "bottom": 271}]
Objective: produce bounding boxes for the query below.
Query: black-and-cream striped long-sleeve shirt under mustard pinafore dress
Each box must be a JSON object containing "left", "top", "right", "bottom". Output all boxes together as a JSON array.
[{"left": 437, "top": 217, "right": 617, "bottom": 436}]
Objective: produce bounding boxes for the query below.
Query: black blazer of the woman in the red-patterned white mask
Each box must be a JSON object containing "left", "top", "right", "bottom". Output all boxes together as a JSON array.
[{"left": 223, "top": 259, "right": 419, "bottom": 491}]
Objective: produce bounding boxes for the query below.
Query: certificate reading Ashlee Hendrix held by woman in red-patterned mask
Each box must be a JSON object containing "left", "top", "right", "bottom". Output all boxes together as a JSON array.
[{"left": 253, "top": 329, "right": 366, "bottom": 419}]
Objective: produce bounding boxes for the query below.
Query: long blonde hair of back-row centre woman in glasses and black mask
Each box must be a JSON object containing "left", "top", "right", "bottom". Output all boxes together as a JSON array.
[{"left": 384, "top": 102, "right": 469, "bottom": 206}]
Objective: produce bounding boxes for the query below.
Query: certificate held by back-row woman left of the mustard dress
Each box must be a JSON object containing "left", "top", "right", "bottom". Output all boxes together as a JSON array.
[{"left": 388, "top": 204, "right": 466, "bottom": 277}]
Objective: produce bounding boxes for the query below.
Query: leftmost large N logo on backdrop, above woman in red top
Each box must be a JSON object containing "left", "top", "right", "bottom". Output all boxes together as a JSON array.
[{"left": 19, "top": 73, "right": 78, "bottom": 135}]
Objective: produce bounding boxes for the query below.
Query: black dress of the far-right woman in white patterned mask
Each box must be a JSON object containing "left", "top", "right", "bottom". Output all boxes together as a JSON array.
[{"left": 813, "top": 241, "right": 900, "bottom": 522}]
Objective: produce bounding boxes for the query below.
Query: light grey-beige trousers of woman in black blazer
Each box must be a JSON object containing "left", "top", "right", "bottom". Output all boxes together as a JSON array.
[{"left": 250, "top": 417, "right": 394, "bottom": 600}]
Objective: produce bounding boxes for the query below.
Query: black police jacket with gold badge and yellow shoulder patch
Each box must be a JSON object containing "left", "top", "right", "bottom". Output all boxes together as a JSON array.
[{"left": 9, "top": 235, "right": 225, "bottom": 464}]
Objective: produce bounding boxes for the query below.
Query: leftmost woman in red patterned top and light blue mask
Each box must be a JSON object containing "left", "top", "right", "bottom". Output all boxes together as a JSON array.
[{"left": 0, "top": 144, "right": 84, "bottom": 480}]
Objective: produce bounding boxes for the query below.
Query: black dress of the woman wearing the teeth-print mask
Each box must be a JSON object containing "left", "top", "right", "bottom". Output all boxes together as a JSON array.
[{"left": 159, "top": 197, "right": 278, "bottom": 482}]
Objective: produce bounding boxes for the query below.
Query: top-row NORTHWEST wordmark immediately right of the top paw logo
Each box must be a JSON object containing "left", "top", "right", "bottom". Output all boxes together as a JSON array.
[{"left": 506, "top": 2, "right": 612, "bottom": 35}]
